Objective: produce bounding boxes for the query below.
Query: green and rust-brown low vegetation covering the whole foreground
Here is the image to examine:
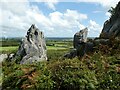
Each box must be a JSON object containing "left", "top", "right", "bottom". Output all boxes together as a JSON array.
[{"left": 2, "top": 38, "right": 120, "bottom": 90}]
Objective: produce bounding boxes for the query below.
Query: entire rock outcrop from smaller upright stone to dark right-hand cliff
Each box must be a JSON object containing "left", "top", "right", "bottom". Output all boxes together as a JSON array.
[{"left": 64, "top": 2, "right": 120, "bottom": 58}]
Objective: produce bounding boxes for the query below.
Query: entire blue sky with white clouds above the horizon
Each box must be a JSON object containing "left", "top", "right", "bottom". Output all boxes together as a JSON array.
[{"left": 0, "top": 0, "right": 119, "bottom": 37}]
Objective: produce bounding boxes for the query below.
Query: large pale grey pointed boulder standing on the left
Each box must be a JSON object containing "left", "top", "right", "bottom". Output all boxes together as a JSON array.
[{"left": 16, "top": 25, "right": 47, "bottom": 64}]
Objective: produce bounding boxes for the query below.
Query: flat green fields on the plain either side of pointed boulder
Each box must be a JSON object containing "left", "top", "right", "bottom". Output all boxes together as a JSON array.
[{"left": 0, "top": 39, "right": 72, "bottom": 53}]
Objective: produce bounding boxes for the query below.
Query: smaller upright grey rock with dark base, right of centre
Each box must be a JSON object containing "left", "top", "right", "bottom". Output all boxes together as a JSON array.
[{"left": 64, "top": 28, "right": 94, "bottom": 58}]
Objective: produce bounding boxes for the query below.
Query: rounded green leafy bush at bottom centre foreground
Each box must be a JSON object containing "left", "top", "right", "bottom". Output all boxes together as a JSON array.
[{"left": 49, "top": 59, "right": 97, "bottom": 90}]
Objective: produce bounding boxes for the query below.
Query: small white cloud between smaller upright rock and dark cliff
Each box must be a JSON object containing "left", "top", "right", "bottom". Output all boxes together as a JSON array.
[{"left": 88, "top": 20, "right": 102, "bottom": 37}]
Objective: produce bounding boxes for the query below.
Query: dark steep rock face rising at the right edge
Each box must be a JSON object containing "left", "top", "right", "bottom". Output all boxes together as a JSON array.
[{"left": 100, "top": 2, "right": 120, "bottom": 39}]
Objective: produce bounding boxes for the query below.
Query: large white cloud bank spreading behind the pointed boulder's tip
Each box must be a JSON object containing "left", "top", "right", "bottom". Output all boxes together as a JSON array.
[{"left": 0, "top": 2, "right": 87, "bottom": 37}]
